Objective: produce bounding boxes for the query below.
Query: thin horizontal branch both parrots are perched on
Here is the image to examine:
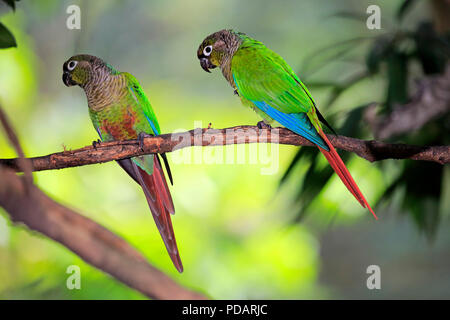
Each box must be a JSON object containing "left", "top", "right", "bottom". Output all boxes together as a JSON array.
[{"left": 0, "top": 126, "right": 450, "bottom": 171}]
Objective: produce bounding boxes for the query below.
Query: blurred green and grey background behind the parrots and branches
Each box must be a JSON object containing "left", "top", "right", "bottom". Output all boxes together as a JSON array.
[{"left": 0, "top": 0, "right": 450, "bottom": 299}]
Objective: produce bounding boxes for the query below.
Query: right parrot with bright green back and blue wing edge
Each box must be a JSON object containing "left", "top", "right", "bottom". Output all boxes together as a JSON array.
[{"left": 197, "top": 30, "right": 377, "bottom": 219}]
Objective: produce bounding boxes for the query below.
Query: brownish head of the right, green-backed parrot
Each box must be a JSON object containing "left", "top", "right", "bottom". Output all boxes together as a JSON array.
[{"left": 197, "top": 29, "right": 240, "bottom": 72}]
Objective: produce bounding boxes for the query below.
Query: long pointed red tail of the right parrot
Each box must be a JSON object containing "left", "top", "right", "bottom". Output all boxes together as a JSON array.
[{"left": 319, "top": 130, "right": 378, "bottom": 220}]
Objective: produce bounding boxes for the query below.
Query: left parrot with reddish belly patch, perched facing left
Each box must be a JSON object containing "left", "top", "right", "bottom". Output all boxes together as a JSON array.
[{"left": 62, "top": 54, "right": 183, "bottom": 272}]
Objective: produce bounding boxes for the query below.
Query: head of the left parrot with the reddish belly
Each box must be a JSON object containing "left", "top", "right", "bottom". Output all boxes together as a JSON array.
[{"left": 62, "top": 54, "right": 113, "bottom": 87}]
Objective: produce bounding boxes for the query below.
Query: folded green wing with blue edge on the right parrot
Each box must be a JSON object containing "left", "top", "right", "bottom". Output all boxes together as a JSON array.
[{"left": 231, "top": 42, "right": 328, "bottom": 150}]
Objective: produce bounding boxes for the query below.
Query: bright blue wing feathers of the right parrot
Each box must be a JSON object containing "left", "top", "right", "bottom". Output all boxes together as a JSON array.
[{"left": 252, "top": 101, "right": 330, "bottom": 151}]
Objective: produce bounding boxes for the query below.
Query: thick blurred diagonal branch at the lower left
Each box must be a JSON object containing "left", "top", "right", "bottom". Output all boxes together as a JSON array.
[{"left": 0, "top": 166, "right": 204, "bottom": 299}]
